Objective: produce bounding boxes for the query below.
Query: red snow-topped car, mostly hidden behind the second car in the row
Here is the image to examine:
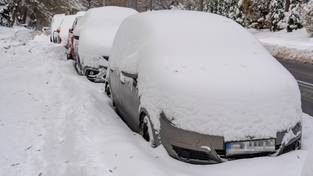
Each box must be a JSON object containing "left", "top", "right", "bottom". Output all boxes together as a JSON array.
[{"left": 66, "top": 16, "right": 83, "bottom": 60}]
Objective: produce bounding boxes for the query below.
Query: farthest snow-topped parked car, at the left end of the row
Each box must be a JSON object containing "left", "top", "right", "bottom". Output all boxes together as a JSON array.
[{"left": 50, "top": 14, "right": 65, "bottom": 43}]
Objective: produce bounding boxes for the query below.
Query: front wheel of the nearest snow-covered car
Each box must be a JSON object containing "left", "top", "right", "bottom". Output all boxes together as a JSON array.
[{"left": 140, "top": 115, "right": 157, "bottom": 148}]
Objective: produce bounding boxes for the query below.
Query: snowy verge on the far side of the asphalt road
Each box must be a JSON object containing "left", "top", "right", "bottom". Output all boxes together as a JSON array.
[{"left": 251, "top": 29, "right": 313, "bottom": 64}]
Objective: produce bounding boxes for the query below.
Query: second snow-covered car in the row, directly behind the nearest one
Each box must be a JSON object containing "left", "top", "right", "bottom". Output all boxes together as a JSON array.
[{"left": 74, "top": 6, "right": 137, "bottom": 82}]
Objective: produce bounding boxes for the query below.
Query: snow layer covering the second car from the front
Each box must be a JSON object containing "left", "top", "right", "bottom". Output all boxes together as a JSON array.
[{"left": 78, "top": 7, "right": 137, "bottom": 67}]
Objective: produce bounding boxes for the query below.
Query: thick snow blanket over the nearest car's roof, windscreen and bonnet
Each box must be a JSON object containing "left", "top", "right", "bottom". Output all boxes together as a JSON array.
[{"left": 110, "top": 11, "right": 302, "bottom": 141}]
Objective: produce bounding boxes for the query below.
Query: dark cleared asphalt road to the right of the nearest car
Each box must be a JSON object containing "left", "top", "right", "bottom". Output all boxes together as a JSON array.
[{"left": 279, "top": 60, "right": 313, "bottom": 116}]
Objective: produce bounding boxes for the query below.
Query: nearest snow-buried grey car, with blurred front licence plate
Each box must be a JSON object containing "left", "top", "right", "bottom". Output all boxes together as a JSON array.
[{"left": 108, "top": 11, "right": 302, "bottom": 163}]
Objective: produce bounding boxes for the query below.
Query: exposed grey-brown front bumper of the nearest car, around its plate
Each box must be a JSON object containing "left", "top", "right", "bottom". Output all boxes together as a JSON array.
[{"left": 160, "top": 114, "right": 302, "bottom": 164}]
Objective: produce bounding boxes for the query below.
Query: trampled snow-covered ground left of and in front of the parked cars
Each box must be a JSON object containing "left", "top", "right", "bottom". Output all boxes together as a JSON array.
[{"left": 0, "top": 28, "right": 313, "bottom": 176}]
